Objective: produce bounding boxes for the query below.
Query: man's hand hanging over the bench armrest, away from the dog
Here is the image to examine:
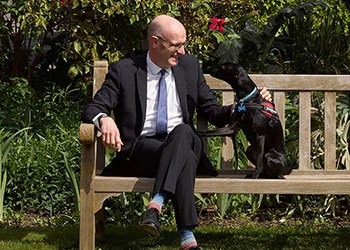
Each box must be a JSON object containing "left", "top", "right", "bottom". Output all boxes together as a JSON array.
[{"left": 100, "top": 116, "right": 124, "bottom": 152}]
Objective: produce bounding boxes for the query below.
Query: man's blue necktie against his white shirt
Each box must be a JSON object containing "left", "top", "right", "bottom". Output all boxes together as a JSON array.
[{"left": 156, "top": 69, "right": 168, "bottom": 135}]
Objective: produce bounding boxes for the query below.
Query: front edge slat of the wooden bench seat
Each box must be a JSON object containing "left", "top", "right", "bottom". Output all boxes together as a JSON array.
[{"left": 94, "top": 176, "right": 350, "bottom": 194}]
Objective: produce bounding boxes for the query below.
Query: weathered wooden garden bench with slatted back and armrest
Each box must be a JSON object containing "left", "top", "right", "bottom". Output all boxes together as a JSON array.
[{"left": 80, "top": 61, "right": 350, "bottom": 250}]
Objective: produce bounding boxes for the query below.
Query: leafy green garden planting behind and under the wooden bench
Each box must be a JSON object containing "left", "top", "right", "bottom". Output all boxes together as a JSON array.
[{"left": 0, "top": 0, "right": 350, "bottom": 231}]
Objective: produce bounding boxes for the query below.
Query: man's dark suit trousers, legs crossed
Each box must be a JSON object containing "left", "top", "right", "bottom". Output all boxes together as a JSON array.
[{"left": 130, "top": 124, "right": 202, "bottom": 229}]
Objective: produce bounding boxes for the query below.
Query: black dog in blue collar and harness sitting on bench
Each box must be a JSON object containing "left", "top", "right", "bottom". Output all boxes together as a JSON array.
[{"left": 206, "top": 62, "right": 292, "bottom": 179}]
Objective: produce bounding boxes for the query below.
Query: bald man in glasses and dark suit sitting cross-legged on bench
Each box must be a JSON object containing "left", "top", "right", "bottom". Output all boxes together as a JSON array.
[{"left": 83, "top": 15, "right": 271, "bottom": 250}]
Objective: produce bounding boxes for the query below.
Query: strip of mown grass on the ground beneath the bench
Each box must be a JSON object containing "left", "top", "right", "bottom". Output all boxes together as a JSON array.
[{"left": 0, "top": 224, "right": 350, "bottom": 250}]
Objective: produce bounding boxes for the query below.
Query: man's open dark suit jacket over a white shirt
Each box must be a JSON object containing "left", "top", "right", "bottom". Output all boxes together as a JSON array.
[{"left": 82, "top": 53, "right": 232, "bottom": 175}]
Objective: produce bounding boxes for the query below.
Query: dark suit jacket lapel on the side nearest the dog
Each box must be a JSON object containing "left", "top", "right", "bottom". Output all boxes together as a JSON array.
[{"left": 173, "top": 65, "right": 189, "bottom": 124}]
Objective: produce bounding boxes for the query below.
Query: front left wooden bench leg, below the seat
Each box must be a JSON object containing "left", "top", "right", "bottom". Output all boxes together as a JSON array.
[{"left": 80, "top": 190, "right": 95, "bottom": 250}]
